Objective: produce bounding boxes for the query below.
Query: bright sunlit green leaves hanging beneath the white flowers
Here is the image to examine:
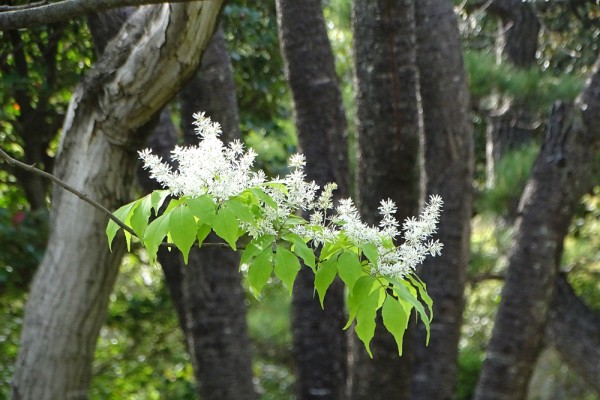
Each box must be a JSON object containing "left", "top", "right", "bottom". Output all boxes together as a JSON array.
[{"left": 106, "top": 186, "right": 433, "bottom": 355}]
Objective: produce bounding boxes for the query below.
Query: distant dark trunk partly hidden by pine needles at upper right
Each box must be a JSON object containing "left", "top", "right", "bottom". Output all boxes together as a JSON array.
[{"left": 487, "top": 0, "right": 540, "bottom": 189}]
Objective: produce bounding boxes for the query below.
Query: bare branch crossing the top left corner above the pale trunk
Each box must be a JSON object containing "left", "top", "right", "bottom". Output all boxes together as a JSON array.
[{"left": 0, "top": 0, "right": 210, "bottom": 31}]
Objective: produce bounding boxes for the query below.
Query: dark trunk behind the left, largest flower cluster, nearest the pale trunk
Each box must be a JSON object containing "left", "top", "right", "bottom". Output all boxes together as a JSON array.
[{"left": 178, "top": 29, "right": 257, "bottom": 400}]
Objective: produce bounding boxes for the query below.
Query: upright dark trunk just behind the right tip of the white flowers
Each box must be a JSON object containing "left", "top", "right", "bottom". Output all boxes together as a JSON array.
[{"left": 412, "top": 0, "right": 473, "bottom": 400}]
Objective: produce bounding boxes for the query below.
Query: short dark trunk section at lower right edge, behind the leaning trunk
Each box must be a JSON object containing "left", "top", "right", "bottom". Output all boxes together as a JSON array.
[{"left": 545, "top": 275, "right": 600, "bottom": 394}]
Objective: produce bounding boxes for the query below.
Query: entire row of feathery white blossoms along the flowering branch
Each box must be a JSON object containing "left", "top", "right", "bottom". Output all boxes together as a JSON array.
[{"left": 140, "top": 113, "right": 443, "bottom": 278}]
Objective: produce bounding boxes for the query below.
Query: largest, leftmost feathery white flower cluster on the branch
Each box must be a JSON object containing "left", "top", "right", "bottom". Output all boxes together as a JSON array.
[{"left": 139, "top": 113, "right": 265, "bottom": 201}]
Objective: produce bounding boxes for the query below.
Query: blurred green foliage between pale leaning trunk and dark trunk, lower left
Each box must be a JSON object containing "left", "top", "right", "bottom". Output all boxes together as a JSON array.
[{"left": 90, "top": 254, "right": 197, "bottom": 400}]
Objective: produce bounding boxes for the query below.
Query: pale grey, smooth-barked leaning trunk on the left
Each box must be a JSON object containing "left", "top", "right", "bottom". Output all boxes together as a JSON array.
[{"left": 12, "top": 1, "right": 221, "bottom": 400}]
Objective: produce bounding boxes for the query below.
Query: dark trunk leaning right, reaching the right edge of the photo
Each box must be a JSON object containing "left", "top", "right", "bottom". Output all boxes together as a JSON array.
[{"left": 475, "top": 59, "right": 600, "bottom": 400}]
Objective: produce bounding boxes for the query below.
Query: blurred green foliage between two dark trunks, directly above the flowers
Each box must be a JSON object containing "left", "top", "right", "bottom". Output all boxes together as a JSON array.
[{"left": 223, "top": 0, "right": 296, "bottom": 175}]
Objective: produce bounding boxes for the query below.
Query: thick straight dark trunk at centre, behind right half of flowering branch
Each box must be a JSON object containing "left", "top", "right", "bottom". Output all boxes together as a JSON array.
[{"left": 351, "top": 0, "right": 422, "bottom": 399}]
